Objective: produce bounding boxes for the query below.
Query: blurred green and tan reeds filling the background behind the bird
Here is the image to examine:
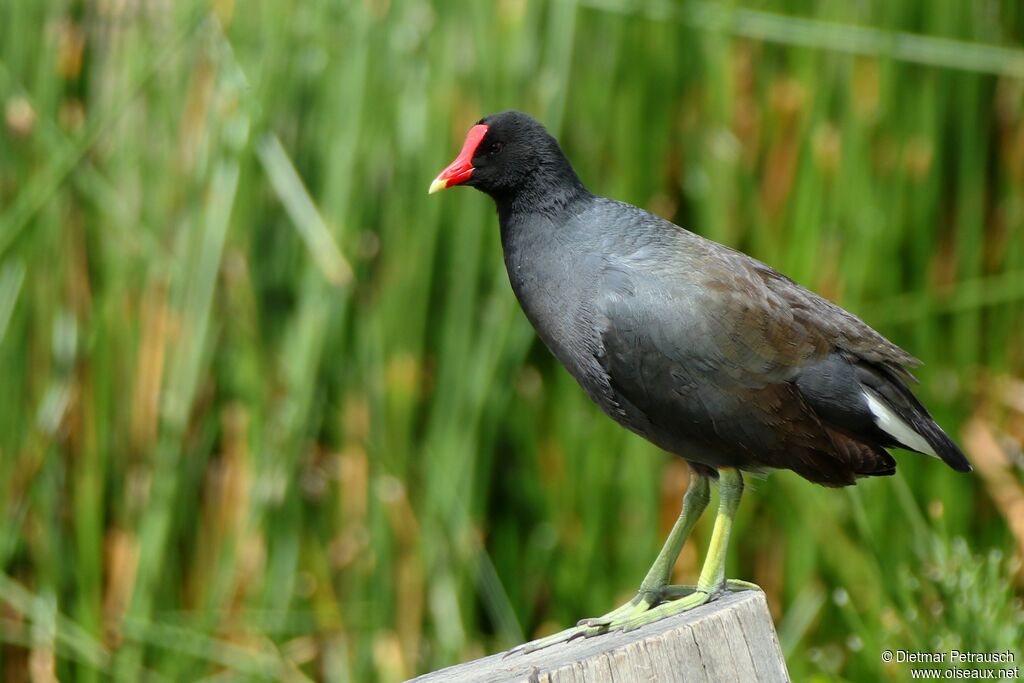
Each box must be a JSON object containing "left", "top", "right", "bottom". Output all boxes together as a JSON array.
[{"left": 0, "top": 0, "right": 1024, "bottom": 681}]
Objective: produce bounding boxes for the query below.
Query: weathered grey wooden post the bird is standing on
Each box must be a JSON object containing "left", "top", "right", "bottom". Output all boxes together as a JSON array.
[{"left": 414, "top": 591, "right": 790, "bottom": 683}]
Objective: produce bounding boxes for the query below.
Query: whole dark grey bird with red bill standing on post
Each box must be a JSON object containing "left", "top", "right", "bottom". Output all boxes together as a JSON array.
[{"left": 429, "top": 111, "right": 971, "bottom": 651}]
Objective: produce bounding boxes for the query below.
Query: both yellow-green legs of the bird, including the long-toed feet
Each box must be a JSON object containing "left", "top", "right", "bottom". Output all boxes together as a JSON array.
[{"left": 514, "top": 468, "right": 757, "bottom": 652}]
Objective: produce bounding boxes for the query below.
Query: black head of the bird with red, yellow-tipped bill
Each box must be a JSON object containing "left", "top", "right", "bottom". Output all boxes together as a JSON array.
[{"left": 430, "top": 111, "right": 583, "bottom": 202}]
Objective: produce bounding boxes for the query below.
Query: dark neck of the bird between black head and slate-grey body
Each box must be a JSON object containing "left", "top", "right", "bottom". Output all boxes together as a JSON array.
[{"left": 490, "top": 158, "right": 592, "bottom": 229}]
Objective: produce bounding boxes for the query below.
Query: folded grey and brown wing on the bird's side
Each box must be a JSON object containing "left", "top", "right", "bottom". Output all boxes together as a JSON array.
[{"left": 602, "top": 241, "right": 915, "bottom": 485}]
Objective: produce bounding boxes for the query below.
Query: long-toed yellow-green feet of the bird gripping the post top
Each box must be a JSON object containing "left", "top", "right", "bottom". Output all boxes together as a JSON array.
[{"left": 506, "top": 580, "right": 761, "bottom": 656}]
